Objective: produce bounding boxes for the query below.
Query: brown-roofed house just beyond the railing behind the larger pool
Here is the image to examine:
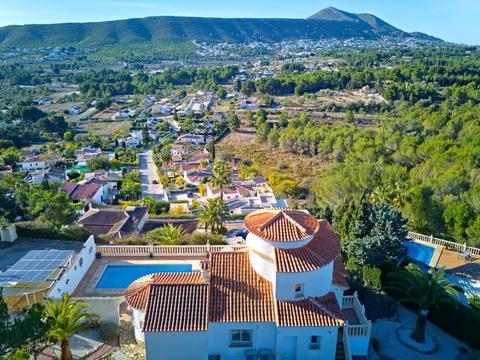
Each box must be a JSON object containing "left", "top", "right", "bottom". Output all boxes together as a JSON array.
[{"left": 77, "top": 206, "right": 148, "bottom": 238}]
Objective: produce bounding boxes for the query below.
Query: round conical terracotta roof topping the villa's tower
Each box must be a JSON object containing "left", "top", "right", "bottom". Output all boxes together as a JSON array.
[{"left": 245, "top": 209, "right": 318, "bottom": 242}]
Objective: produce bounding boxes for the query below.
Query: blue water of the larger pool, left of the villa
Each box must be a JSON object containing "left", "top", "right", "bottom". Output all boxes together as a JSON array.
[{"left": 95, "top": 264, "right": 192, "bottom": 289}]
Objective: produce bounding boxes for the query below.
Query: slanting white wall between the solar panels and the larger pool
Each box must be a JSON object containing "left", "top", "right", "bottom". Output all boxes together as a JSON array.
[{"left": 47, "top": 235, "right": 95, "bottom": 299}]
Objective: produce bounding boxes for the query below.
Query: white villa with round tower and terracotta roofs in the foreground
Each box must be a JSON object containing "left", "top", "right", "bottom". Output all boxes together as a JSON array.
[{"left": 125, "top": 209, "right": 371, "bottom": 360}]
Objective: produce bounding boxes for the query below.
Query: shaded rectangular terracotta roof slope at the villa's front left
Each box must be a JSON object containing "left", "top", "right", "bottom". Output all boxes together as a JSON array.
[{"left": 143, "top": 284, "right": 209, "bottom": 332}]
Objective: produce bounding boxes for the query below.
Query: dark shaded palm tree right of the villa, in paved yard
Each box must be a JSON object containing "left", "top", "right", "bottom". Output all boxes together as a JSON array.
[{"left": 387, "top": 264, "right": 458, "bottom": 343}]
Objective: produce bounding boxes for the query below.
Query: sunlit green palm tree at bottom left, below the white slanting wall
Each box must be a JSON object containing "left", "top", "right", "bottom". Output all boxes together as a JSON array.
[{"left": 45, "top": 295, "right": 99, "bottom": 360}]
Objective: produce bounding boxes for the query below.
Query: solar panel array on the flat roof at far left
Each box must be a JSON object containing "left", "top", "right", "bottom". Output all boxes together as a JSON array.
[{"left": 0, "top": 250, "right": 73, "bottom": 283}]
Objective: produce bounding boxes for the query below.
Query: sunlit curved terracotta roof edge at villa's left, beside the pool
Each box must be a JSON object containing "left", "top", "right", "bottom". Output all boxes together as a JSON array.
[{"left": 124, "top": 272, "right": 206, "bottom": 310}]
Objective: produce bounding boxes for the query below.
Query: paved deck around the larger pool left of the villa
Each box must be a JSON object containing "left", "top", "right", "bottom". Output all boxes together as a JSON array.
[{"left": 73, "top": 256, "right": 205, "bottom": 298}]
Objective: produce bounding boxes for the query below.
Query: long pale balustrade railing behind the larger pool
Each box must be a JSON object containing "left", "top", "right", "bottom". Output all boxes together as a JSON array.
[{"left": 96, "top": 245, "right": 246, "bottom": 257}]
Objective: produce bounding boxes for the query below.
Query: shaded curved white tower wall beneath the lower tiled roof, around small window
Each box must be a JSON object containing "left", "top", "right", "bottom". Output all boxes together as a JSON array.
[{"left": 274, "top": 262, "right": 333, "bottom": 301}]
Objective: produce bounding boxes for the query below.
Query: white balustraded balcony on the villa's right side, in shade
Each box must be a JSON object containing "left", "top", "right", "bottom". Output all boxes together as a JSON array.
[{"left": 341, "top": 292, "right": 372, "bottom": 360}]
